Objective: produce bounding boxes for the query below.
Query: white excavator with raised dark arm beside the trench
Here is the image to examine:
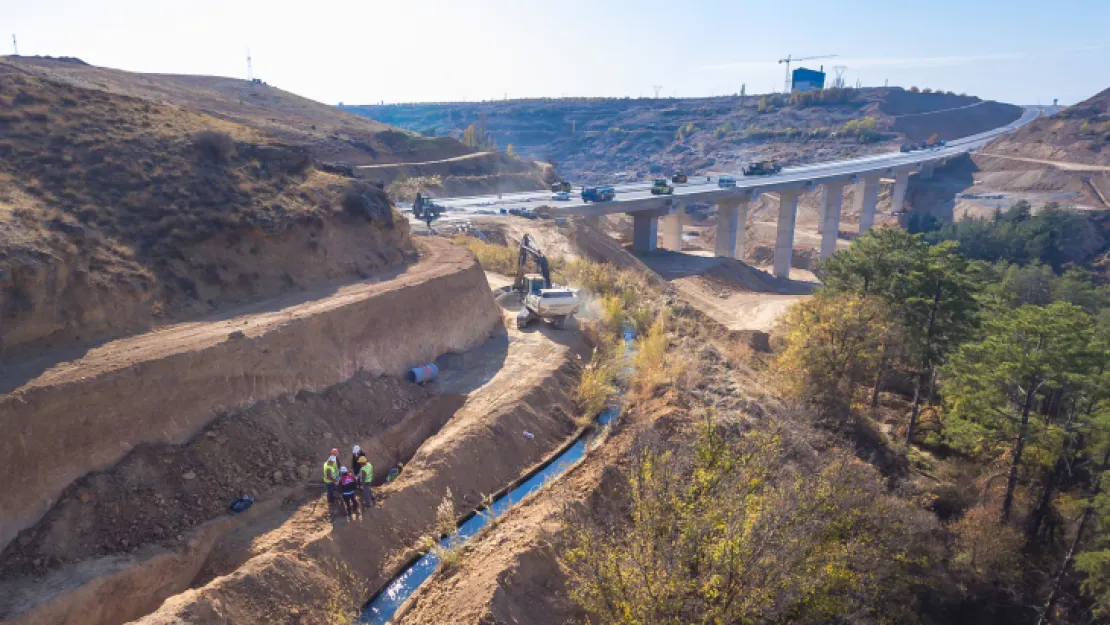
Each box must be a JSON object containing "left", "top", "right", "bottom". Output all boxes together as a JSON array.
[{"left": 513, "top": 234, "right": 578, "bottom": 330}]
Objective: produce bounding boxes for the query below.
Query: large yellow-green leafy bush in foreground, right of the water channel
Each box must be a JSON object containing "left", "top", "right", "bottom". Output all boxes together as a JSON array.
[{"left": 561, "top": 425, "right": 926, "bottom": 625}]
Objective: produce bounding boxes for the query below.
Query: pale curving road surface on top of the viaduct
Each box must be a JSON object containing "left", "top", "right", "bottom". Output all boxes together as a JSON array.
[{"left": 426, "top": 107, "right": 1040, "bottom": 216}]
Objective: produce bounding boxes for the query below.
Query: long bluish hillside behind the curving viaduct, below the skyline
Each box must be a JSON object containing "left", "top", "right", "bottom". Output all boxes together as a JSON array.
[{"left": 344, "top": 89, "right": 1021, "bottom": 182}]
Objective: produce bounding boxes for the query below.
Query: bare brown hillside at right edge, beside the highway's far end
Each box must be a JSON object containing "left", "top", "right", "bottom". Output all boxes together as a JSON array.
[{"left": 982, "top": 89, "right": 1110, "bottom": 165}]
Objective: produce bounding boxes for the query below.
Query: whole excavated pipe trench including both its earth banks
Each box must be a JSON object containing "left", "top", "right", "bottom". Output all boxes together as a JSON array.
[{"left": 0, "top": 240, "right": 589, "bottom": 625}]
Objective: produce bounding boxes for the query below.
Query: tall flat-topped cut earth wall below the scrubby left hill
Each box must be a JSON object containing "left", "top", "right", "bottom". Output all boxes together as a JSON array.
[{"left": 0, "top": 241, "right": 501, "bottom": 552}]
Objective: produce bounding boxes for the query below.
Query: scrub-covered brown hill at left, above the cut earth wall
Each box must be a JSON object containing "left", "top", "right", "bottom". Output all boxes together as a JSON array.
[{"left": 0, "top": 67, "right": 413, "bottom": 355}]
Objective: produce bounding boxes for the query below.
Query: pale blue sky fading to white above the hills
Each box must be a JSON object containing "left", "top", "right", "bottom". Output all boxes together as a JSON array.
[{"left": 8, "top": 0, "right": 1110, "bottom": 104}]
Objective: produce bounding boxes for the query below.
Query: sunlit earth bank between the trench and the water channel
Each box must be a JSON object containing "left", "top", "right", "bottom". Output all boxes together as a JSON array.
[{"left": 129, "top": 317, "right": 587, "bottom": 625}]
